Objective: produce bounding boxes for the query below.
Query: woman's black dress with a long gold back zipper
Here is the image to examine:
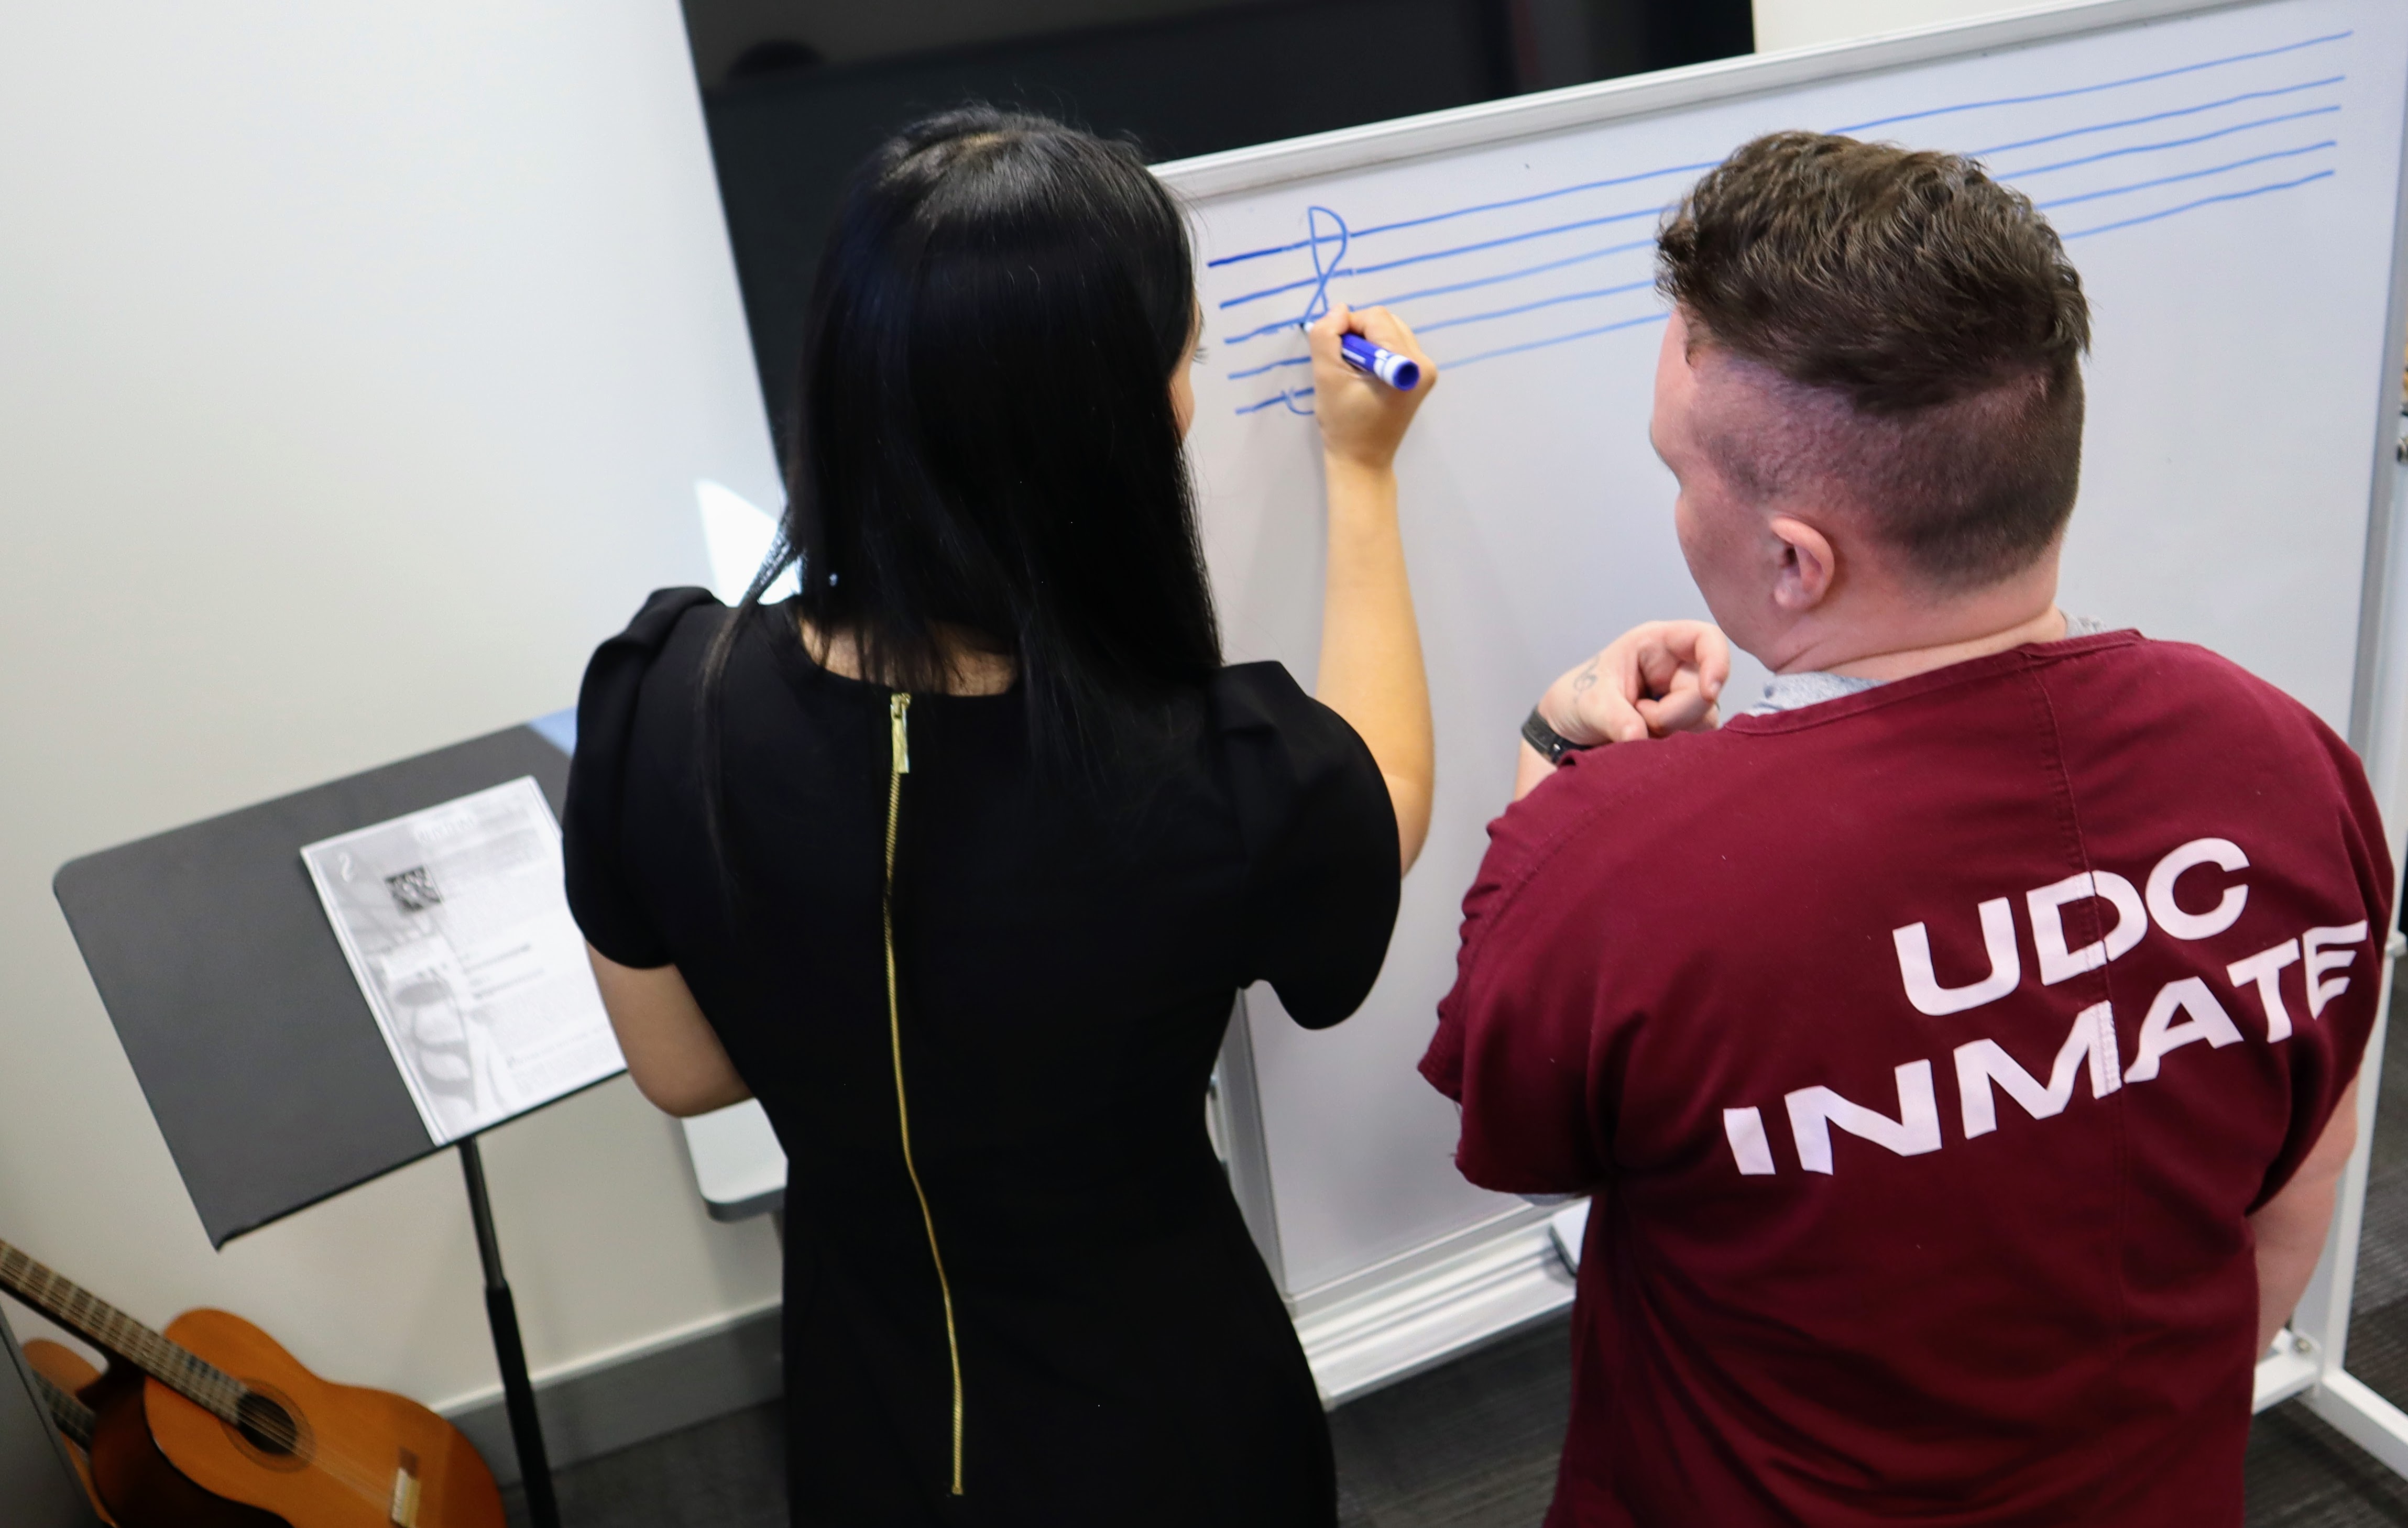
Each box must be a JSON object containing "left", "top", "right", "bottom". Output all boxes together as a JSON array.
[{"left": 563, "top": 589, "right": 1397, "bottom": 1528}]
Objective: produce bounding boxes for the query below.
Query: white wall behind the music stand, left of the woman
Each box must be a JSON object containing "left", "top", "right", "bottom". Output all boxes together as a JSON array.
[{"left": 0, "top": 0, "right": 778, "bottom": 1403}]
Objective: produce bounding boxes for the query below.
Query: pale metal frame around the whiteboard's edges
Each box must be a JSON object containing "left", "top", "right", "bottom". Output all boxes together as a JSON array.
[{"left": 1156, "top": 0, "right": 2408, "bottom": 1444}]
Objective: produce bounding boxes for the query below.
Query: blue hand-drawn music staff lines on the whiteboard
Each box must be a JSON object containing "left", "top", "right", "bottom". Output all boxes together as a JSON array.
[{"left": 1207, "top": 31, "right": 2350, "bottom": 416}]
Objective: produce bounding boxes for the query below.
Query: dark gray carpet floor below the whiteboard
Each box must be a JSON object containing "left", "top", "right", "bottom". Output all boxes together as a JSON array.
[{"left": 510, "top": 982, "right": 2408, "bottom": 1528}]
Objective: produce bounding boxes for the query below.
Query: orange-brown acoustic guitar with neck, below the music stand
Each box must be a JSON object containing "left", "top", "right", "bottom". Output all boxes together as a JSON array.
[{"left": 0, "top": 1241, "right": 504, "bottom": 1528}]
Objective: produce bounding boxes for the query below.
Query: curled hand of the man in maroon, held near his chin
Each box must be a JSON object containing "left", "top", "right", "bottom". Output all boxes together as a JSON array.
[{"left": 1515, "top": 621, "right": 1732, "bottom": 801}]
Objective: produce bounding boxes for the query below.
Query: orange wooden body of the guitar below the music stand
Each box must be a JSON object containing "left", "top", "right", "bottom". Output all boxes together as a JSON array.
[{"left": 134, "top": 1312, "right": 504, "bottom": 1528}]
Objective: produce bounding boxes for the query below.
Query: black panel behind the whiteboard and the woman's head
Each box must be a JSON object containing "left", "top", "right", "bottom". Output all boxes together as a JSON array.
[{"left": 686, "top": 0, "right": 1755, "bottom": 435}]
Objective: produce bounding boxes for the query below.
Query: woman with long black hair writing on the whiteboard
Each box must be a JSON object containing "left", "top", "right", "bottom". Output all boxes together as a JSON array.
[{"left": 566, "top": 108, "right": 1430, "bottom": 1528}]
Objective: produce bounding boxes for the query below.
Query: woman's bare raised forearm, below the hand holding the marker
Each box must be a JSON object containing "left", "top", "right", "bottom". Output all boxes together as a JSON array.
[{"left": 1317, "top": 455, "right": 1435, "bottom": 869}]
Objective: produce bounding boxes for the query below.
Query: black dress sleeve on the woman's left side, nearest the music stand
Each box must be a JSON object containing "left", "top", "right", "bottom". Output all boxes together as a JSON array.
[{"left": 561, "top": 589, "right": 715, "bottom": 970}]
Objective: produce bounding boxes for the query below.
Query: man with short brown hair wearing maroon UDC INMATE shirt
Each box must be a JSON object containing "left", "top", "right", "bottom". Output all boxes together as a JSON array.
[{"left": 1423, "top": 135, "right": 2391, "bottom": 1528}]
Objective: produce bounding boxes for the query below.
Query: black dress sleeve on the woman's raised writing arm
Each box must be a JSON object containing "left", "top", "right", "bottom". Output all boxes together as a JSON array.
[{"left": 1213, "top": 664, "right": 1402, "bottom": 1030}]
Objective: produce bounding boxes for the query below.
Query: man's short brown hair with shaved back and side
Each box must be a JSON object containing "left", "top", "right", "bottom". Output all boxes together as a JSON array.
[{"left": 1657, "top": 133, "right": 2090, "bottom": 587}]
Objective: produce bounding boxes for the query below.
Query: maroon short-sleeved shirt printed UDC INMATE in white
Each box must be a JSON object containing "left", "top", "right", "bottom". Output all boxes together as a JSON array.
[{"left": 1421, "top": 633, "right": 2391, "bottom": 1528}]
